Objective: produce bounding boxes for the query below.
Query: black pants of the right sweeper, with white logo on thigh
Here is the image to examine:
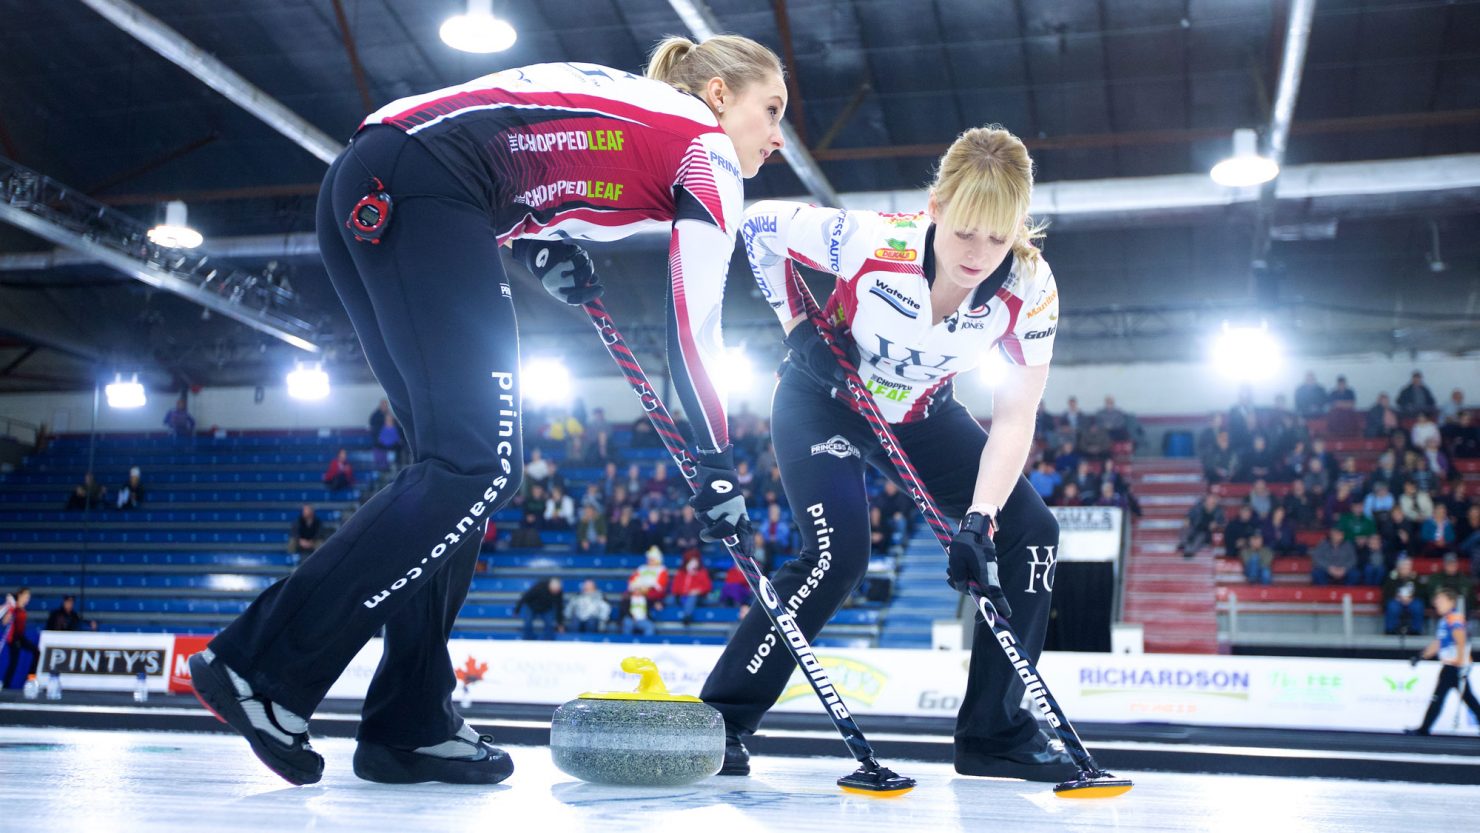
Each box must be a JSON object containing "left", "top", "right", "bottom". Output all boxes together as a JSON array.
[{"left": 700, "top": 365, "right": 1058, "bottom": 755}]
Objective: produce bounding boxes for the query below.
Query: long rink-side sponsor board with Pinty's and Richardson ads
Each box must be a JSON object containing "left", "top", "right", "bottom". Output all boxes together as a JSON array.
[{"left": 40, "top": 632, "right": 1477, "bottom": 732}]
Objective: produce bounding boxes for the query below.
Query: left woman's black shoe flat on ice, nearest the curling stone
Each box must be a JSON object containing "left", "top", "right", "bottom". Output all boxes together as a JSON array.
[{"left": 354, "top": 722, "right": 514, "bottom": 784}]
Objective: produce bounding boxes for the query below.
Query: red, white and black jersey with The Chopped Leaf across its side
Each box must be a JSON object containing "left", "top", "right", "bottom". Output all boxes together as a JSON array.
[{"left": 364, "top": 64, "right": 744, "bottom": 450}]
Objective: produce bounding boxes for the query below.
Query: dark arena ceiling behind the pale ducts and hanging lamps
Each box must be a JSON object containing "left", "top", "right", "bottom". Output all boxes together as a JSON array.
[{"left": 0, "top": 0, "right": 1480, "bottom": 391}]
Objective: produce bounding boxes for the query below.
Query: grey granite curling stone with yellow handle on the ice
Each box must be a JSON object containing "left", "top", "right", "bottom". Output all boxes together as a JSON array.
[{"left": 551, "top": 657, "right": 725, "bottom": 787}]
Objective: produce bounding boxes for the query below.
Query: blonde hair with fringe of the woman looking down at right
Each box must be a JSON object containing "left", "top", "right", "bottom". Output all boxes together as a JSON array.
[{"left": 929, "top": 124, "right": 1046, "bottom": 260}]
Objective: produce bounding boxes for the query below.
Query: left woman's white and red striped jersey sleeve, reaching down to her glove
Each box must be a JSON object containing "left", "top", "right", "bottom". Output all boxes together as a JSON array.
[{"left": 667, "top": 133, "right": 743, "bottom": 451}]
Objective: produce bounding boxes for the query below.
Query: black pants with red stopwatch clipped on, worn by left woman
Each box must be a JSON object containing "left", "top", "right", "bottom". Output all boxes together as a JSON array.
[{"left": 210, "top": 126, "right": 524, "bottom": 747}]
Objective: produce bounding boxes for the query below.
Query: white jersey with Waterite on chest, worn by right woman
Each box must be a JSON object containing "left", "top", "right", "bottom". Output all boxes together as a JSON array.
[{"left": 740, "top": 200, "right": 1058, "bottom": 423}]
